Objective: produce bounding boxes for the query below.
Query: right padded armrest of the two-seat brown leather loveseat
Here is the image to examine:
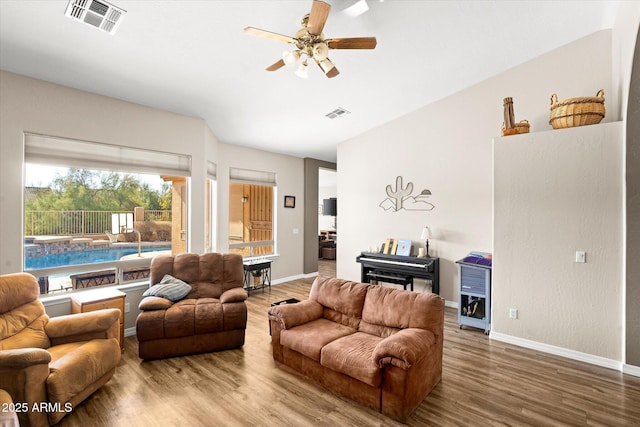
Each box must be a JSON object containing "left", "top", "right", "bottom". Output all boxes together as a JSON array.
[{"left": 373, "top": 328, "right": 436, "bottom": 369}]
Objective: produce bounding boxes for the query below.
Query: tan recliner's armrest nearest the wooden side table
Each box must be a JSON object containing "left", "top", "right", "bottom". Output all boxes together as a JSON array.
[{"left": 45, "top": 308, "right": 120, "bottom": 345}]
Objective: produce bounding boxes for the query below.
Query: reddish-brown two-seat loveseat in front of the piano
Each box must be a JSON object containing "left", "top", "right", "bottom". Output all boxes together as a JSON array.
[{"left": 269, "top": 277, "right": 444, "bottom": 422}]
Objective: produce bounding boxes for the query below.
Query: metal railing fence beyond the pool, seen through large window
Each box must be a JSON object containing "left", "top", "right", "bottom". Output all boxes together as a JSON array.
[{"left": 24, "top": 210, "right": 171, "bottom": 236}]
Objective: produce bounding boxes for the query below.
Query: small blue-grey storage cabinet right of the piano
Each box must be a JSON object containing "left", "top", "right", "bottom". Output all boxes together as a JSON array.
[{"left": 457, "top": 256, "right": 491, "bottom": 335}]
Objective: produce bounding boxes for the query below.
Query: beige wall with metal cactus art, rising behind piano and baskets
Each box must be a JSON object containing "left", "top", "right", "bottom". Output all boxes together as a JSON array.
[{"left": 337, "top": 31, "right": 618, "bottom": 303}]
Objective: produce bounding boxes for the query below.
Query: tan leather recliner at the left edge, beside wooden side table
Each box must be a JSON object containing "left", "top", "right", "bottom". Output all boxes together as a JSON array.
[{"left": 0, "top": 273, "right": 121, "bottom": 426}]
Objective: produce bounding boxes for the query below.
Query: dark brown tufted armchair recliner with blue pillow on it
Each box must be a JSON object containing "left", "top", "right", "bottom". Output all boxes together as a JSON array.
[{"left": 136, "top": 253, "right": 247, "bottom": 359}]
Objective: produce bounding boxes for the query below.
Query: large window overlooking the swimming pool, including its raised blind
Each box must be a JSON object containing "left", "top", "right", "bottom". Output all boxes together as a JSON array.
[{"left": 23, "top": 134, "right": 190, "bottom": 294}]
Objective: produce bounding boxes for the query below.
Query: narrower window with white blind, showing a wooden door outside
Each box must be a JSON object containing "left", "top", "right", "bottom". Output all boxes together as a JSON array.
[{"left": 229, "top": 168, "right": 276, "bottom": 257}]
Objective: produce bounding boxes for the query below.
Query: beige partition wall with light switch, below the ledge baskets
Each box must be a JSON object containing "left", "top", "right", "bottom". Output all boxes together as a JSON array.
[{"left": 492, "top": 122, "right": 624, "bottom": 361}]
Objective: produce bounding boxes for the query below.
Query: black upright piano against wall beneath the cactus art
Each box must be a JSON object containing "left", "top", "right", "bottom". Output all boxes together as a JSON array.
[{"left": 356, "top": 252, "right": 440, "bottom": 294}]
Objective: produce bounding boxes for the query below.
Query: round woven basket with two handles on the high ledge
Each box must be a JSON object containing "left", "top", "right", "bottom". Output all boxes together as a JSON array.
[{"left": 549, "top": 89, "right": 605, "bottom": 129}]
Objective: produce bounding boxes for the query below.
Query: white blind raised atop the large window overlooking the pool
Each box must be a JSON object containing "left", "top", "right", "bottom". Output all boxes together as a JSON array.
[{"left": 25, "top": 133, "right": 191, "bottom": 176}]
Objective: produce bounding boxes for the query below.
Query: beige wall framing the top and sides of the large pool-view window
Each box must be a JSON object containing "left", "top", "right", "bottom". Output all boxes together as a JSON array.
[{"left": 0, "top": 71, "right": 207, "bottom": 273}]
